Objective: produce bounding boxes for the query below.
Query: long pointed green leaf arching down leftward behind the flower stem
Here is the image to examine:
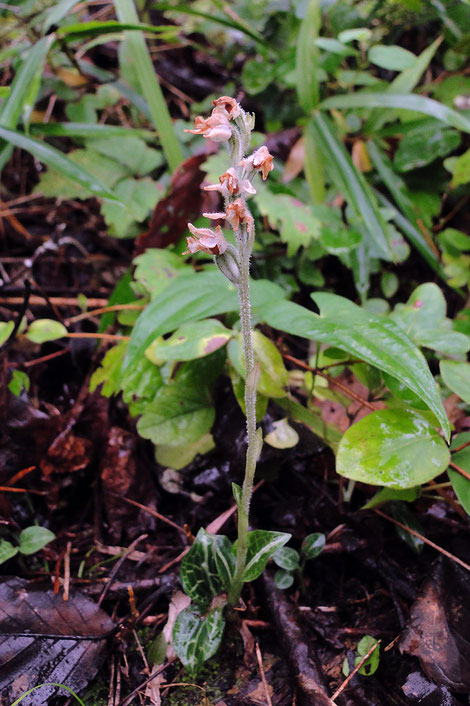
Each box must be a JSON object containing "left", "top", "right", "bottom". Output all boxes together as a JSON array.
[{"left": 122, "top": 272, "right": 285, "bottom": 375}]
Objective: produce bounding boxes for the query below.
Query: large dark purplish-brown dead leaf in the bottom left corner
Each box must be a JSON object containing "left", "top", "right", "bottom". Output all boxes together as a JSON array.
[{"left": 0, "top": 577, "right": 115, "bottom": 706}]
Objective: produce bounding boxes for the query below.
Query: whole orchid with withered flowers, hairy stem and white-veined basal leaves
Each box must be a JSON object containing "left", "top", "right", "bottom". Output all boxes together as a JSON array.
[{"left": 173, "top": 96, "right": 290, "bottom": 669}]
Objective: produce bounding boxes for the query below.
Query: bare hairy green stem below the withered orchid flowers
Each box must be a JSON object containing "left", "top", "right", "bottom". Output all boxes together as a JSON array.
[{"left": 228, "top": 236, "right": 260, "bottom": 605}]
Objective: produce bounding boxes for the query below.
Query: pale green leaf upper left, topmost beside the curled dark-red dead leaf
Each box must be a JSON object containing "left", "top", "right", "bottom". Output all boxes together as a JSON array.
[{"left": 87, "top": 135, "right": 163, "bottom": 176}]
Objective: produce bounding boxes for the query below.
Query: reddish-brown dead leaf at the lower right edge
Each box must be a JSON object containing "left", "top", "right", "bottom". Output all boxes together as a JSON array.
[{"left": 399, "top": 561, "right": 470, "bottom": 694}]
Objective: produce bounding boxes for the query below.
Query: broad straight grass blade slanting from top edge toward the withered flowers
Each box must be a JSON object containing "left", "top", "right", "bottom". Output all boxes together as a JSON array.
[{"left": 114, "top": 0, "right": 183, "bottom": 172}]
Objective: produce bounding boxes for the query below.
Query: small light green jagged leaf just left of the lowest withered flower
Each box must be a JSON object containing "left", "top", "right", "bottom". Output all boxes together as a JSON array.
[{"left": 133, "top": 248, "right": 187, "bottom": 299}]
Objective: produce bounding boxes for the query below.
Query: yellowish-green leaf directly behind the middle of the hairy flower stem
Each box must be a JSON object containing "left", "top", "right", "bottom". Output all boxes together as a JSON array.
[{"left": 228, "top": 330, "right": 288, "bottom": 397}]
